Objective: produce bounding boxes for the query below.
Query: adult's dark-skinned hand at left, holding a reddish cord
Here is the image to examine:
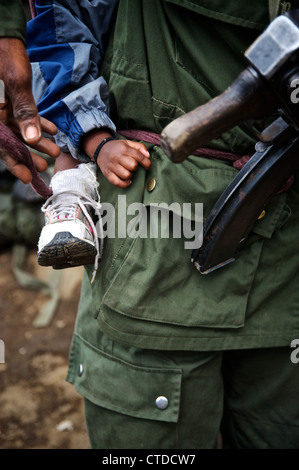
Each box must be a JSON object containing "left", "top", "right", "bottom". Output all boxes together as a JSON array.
[{"left": 0, "top": 37, "right": 60, "bottom": 183}]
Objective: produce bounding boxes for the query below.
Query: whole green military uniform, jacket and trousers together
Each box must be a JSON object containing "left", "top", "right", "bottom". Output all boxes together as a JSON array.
[{"left": 68, "top": 0, "right": 299, "bottom": 448}]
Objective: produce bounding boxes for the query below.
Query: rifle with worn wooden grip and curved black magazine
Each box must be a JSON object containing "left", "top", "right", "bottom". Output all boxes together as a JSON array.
[{"left": 161, "top": 10, "right": 299, "bottom": 274}]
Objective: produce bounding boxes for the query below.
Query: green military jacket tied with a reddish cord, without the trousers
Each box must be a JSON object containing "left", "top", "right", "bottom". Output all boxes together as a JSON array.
[{"left": 71, "top": 0, "right": 299, "bottom": 350}]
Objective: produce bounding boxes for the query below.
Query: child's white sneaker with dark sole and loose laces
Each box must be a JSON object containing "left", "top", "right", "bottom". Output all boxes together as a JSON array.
[{"left": 37, "top": 163, "right": 103, "bottom": 280}]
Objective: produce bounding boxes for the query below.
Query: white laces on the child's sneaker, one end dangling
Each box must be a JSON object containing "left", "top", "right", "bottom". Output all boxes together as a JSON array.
[{"left": 41, "top": 191, "right": 104, "bottom": 284}]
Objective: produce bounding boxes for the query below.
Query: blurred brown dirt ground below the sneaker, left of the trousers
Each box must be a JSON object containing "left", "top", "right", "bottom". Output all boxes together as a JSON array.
[{"left": 0, "top": 249, "right": 90, "bottom": 449}]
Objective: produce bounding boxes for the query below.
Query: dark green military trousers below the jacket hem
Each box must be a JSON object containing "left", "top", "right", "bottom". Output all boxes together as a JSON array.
[{"left": 79, "top": 337, "right": 299, "bottom": 449}]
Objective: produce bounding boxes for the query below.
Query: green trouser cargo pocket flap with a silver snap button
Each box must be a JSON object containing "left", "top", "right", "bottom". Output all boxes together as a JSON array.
[{"left": 67, "top": 335, "right": 182, "bottom": 423}]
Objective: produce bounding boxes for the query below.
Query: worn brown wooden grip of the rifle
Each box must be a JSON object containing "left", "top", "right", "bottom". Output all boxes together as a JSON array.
[{"left": 161, "top": 67, "right": 276, "bottom": 163}]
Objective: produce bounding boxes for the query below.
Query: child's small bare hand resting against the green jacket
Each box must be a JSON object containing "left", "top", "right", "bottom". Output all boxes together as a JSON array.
[{"left": 97, "top": 140, "right": 151, "bottom": 188}]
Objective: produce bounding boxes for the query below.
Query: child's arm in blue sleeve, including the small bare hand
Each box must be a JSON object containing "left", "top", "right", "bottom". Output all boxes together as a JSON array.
[{"left": 27, "top": 0, "right": 150, "bottom": 188}]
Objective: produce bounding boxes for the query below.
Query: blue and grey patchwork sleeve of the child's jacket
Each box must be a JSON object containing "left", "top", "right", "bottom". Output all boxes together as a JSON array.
[{"left": 26, "top": 0, "right": 118, "bottom": 161}]
